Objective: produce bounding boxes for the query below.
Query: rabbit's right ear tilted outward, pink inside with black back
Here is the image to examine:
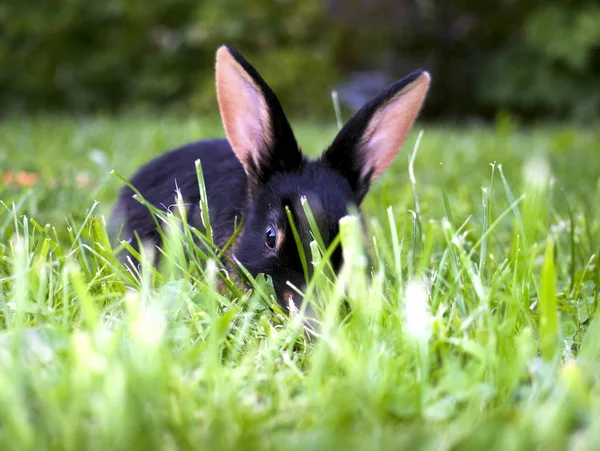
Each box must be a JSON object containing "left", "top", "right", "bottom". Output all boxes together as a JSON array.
[{"left": 322, "top": 71, "right": 430, "bottom": 203}]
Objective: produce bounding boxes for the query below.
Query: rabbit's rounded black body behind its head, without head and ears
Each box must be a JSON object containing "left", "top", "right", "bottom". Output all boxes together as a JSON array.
[{"left": 109, "top": 139, "right": 248, "bottom": 254}]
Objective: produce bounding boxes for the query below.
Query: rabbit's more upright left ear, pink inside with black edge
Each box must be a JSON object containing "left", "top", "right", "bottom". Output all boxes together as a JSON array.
[{"left": 216, "top": 46, "right": 302, "bottom": 184}]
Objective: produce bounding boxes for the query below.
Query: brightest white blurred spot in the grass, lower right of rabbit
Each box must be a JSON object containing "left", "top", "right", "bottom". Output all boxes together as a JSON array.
[{"left": 404, "top": 277, "right": 431, "bottom": 341}]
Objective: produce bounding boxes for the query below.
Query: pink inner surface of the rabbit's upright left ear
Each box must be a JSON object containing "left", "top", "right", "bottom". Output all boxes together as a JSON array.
[{"left": 216, "top": 47, "right": 271, "bottom": 170}]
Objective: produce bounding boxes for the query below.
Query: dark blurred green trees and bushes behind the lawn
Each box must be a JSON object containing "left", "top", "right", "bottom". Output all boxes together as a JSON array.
[{"left": 0, "top": 0, "right": 600, "bottom": 120}]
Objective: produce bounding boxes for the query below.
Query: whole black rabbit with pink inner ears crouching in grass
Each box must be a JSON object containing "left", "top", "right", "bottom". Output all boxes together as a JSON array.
[{"left": 109, "top": 46, "right": 430, "bottom": 309}]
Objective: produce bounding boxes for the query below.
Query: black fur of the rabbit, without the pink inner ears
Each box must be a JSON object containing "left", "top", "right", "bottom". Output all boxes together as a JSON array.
[{"left": 109, "top": 48, "right": 421, "bottom": 314}]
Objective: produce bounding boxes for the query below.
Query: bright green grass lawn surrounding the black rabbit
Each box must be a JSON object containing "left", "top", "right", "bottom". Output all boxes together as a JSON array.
[{"left": 0, "top": 117, "right": 600, "bottom": 450}]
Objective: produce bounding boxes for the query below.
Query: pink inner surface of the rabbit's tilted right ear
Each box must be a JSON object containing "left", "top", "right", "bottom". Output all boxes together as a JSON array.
[{"left": 361, "top": 72, "right": 430, "bottom": 181}]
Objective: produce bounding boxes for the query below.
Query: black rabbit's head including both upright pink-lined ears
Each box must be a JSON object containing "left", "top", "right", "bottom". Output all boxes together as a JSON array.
[{"left": 216, "top": 46, "right": 430, "bottom": 309}]
